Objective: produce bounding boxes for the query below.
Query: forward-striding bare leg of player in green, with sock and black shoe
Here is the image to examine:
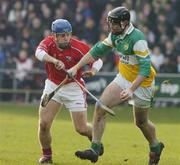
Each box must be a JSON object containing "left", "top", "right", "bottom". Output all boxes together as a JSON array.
[{"left": 75, "top": 82, "right": 122, "bottom": 162}]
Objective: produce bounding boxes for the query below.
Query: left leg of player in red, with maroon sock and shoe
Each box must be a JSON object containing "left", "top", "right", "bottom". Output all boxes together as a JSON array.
[{"left": 38, "top": 100, "right": 61, "bottom": 163}]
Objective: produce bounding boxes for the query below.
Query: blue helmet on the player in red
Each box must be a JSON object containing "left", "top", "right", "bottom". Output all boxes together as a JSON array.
[{"left": 51, "top": 19, "right": 72, "bottom": 33}]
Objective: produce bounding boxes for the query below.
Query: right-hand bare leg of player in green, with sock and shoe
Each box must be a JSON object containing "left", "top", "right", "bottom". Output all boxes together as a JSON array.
[{"left": 133, "top": 97, "right": 164, "bottom": 165}]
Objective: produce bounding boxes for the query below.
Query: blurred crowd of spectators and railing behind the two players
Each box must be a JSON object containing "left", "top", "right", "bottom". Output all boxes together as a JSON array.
[{"left": 0, "top": 0, "right": 180, "bottom": 106}]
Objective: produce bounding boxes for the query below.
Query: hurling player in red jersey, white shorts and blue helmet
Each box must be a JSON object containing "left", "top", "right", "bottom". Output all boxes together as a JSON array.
[{"left": 35, "top": 19, "right": 102, "bottom": 164}]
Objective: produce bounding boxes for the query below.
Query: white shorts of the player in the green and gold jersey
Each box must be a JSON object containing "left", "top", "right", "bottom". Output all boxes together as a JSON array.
[{"left": 113, "top": 74, "right": 154, "bottom": 108}]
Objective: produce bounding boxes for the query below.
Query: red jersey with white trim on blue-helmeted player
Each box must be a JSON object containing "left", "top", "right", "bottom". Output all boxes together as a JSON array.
[{"left": 37, "top": 36, "right": 90, "bottom": 84}]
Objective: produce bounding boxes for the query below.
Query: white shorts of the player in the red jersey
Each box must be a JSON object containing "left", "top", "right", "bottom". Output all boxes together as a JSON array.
[{"left": 41, "top": 79, "right": 87, "bottom": 111}]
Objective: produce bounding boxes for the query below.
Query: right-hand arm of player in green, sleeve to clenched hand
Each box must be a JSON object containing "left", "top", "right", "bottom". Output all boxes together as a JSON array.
[{"left": 121, "top": 40, "right": 151, "bottom": 100}]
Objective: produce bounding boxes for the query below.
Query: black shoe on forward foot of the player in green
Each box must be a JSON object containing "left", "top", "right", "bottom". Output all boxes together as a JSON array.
[{"left": 75, "top": 143, "right": 104, "bottom": 163}]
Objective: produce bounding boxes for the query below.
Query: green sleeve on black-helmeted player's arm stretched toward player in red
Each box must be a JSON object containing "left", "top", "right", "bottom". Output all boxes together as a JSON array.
[{"left": 89, "top": 34, "right": 113, "bottom": 59}]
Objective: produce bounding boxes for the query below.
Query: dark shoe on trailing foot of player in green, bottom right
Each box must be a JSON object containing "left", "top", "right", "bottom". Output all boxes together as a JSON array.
[{"left": 148, "top": 142, "right": 164, "bottom": 165}]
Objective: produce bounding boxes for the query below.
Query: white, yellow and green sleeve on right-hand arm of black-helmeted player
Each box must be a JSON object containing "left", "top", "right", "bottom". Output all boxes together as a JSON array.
[{"left": 133, "top": 40, "right": 151, "bottom": 77}]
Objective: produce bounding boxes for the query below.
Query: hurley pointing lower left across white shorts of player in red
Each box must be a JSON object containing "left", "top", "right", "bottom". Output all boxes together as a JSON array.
[{"left": 41, "top": 76, "right": 68, "bottom": 107}]
